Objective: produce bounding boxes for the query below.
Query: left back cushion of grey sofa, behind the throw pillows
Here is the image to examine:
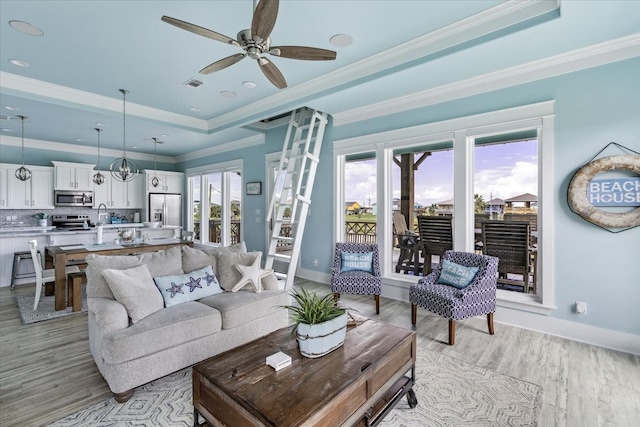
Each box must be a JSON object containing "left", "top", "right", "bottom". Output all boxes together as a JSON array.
[{"left": 85, "top": 247, "right": 184, "bottom": 299}]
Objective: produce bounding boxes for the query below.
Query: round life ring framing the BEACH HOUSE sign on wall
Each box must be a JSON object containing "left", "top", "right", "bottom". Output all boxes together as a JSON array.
[{"left": 567, "top": 143, "right": 640, "bottom": 231}]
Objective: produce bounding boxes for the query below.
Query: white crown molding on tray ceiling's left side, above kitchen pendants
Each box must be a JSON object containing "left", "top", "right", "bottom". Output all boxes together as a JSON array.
[{"left": 0, "top": 71, "right": 208, "bottom": 131}]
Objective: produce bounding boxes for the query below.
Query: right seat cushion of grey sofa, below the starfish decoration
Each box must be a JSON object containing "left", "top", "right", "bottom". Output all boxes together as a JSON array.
[{"left": 198, "top": 290, "right": 291, "bottom": 329}]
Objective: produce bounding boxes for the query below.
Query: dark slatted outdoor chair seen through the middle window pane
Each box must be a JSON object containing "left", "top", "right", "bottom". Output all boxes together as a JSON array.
[{"left": 418, "top": 215, "right": 453, "bottom": 276}]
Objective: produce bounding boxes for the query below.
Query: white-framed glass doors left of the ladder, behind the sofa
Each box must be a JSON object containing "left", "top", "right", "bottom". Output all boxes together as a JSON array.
[{"left": 187, "top": 161, "right": 242, "bottom": 246}]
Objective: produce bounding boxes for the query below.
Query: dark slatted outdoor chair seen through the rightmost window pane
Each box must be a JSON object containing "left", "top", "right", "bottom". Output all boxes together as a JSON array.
[{"left": 482, "top": 221, "right": 535, "bottom": 293}]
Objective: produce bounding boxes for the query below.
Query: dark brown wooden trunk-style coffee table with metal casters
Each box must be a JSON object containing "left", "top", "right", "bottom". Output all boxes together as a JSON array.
[{"left": 193, "top": 318, "right": 417, "bottom": 427}]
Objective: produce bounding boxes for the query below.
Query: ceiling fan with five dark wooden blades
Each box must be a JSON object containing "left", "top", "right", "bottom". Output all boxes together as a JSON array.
[{"left": 162, "top": 0, "right": 336, "bottom": 89}]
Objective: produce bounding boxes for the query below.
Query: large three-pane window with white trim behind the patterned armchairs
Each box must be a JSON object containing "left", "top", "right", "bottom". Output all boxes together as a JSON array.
[{"left": 334, "top": 102, "right": 554, "bottom": 313}]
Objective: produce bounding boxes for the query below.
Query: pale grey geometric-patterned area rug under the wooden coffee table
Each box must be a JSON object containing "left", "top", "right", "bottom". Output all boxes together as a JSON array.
[{"left": 50, "top": 345, "right": 542, "bottom": 427}]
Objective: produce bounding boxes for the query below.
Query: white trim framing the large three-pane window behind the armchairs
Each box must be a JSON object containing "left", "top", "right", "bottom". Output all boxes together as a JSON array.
[{"left": 333, "top": 101, "right": 556, "bottom": 314}]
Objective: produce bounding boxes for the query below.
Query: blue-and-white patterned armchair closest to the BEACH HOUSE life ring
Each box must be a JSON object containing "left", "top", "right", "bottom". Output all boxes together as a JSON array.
[{"left": 409, "top": 251, "right": 498, "bottom": 345}]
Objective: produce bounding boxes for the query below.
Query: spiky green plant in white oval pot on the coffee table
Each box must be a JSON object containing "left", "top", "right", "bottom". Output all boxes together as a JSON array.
[{"left": 283, "top": 289, "right": 348, "bottom": 358}]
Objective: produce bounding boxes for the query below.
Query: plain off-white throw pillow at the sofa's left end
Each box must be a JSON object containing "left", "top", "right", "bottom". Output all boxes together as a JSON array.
[{"left": 102, "top": 264, "right": 164, "bottom": 323}]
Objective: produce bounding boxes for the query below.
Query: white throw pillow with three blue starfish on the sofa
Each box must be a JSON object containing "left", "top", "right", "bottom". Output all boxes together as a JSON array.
[{"left": 153, "top": 265, "right": 224, "bottom": 307}]
